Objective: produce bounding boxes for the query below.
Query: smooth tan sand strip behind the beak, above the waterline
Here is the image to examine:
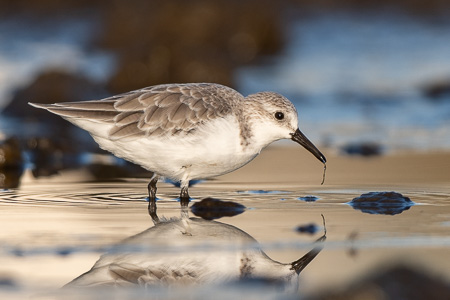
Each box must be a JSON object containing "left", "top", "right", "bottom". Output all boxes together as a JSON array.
[{"left": 218, "top": 145, "right": 450, "bottom": 187}]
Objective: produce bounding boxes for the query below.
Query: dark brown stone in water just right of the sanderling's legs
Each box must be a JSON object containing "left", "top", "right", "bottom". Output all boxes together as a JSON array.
[{"left": 191, "top": 198, "right": 246, "bottom": 220}]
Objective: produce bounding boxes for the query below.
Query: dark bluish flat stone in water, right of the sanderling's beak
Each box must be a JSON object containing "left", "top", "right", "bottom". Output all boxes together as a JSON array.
[{"left": 347, "top": 192, "right": 415, "bottom": 215}]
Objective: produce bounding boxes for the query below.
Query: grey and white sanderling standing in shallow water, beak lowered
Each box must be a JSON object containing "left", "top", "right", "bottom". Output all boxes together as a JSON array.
[{"left": 29, "top": 83, "right": 326, "bottom": 201}]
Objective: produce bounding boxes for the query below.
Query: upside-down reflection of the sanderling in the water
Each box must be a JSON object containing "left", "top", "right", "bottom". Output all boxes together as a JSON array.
[{"left": 66, "top": 218, "right": 325, "bottom": 289}]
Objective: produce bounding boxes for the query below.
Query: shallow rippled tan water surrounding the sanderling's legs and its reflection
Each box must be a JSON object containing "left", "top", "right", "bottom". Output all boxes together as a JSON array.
[{"left": 0, "top": 172, "right": 450, "bottom": 299}]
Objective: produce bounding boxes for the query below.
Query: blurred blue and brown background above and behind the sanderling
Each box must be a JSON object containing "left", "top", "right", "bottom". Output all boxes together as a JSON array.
[{"left": 0, "top": 0, "right": 450, "bottom": 187}]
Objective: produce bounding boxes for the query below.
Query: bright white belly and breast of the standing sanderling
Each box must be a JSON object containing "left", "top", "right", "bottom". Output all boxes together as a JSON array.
[{"left": 81, "top": 119, "right": 260, "bottom": 180}]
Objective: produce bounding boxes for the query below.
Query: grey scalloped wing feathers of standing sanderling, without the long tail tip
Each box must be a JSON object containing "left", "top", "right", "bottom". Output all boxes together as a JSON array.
[{"left": 110, "top": 84, "right": 243, "bottom": 139}]
